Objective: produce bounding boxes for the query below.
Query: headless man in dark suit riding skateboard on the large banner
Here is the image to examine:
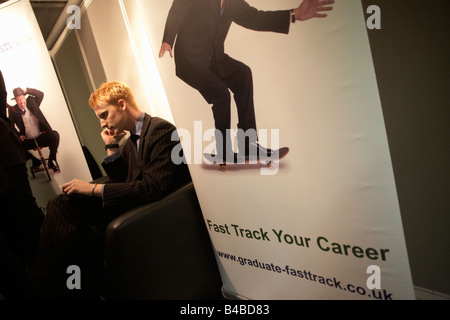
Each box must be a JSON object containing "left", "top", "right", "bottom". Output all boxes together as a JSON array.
[{"left": 159, "top": 0, "right": 334, "bottom": 159}]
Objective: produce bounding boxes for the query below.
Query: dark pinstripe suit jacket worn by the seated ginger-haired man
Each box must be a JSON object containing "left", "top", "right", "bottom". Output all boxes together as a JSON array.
[{"left": 102, "top": 114, "right": 191, "bottom": 207}]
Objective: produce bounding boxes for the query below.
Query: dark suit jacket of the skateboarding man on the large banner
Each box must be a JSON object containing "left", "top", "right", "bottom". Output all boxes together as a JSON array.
[{"left": 163, "top": 0, "right": 290, "bottom": 87}]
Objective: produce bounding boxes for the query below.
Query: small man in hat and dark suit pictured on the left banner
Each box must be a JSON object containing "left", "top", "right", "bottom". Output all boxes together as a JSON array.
[{"left": 9, "top": 88, "right": 59, "bottom": 171}]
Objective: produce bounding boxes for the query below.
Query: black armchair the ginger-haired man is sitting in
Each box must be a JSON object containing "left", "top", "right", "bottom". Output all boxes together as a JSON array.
[{"left": 103, "top": 183, "right": 223, "bottom": 300}]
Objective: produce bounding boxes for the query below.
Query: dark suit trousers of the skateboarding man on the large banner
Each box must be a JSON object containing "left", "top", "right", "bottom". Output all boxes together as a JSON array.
[{"left": 196, "top": 57, "right": 257, "bottom": 155}]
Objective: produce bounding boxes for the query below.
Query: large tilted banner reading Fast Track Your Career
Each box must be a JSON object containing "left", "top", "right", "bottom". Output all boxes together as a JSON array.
[{"left": 138, "top": 0, "right": 414, "bottom": 300}]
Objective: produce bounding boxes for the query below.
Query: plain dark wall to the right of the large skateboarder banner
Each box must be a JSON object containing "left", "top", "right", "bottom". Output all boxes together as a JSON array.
[{"left": 362, "top": 0, "right": 450, "bottom": 294}]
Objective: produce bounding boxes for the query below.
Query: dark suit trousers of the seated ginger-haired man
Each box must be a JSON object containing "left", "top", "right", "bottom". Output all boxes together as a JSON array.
[{"left": 32, "top": 194, "right": 122, "bottom": 299}]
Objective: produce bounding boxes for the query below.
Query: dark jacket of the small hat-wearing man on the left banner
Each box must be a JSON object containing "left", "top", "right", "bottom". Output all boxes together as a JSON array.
[{"left": 9, "top": 88, "right": 52, "bottom": 136}]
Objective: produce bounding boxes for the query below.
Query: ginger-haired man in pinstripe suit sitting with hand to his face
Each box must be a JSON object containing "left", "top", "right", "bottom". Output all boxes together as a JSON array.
[{"left": 33, "top": 82, "right": 191, "bottom": 299}]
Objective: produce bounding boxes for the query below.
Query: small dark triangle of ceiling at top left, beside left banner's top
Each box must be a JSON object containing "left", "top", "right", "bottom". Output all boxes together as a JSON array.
[{"left": 0, "top": 0, "right": 68, "bottom": 40}]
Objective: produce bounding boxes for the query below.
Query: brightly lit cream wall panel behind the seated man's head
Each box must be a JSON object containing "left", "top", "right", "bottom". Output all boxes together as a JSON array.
[{"left": 84, "top": 0, "right": 173, "bottom": 122}]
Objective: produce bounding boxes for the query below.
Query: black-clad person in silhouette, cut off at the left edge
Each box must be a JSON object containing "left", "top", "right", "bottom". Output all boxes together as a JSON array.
[{"left": 0, "top": 72, "right": 44, "bottom": 272}]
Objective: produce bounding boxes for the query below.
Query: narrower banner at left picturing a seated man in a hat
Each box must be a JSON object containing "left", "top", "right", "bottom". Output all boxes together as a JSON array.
[{"left": 0, "top": 0, "right": 92, "bottom": 209}]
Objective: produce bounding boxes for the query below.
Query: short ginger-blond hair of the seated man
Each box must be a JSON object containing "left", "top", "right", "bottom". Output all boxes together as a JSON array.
[{"left": 89, "top": 81, "right": 139, "bottom": 110}]
